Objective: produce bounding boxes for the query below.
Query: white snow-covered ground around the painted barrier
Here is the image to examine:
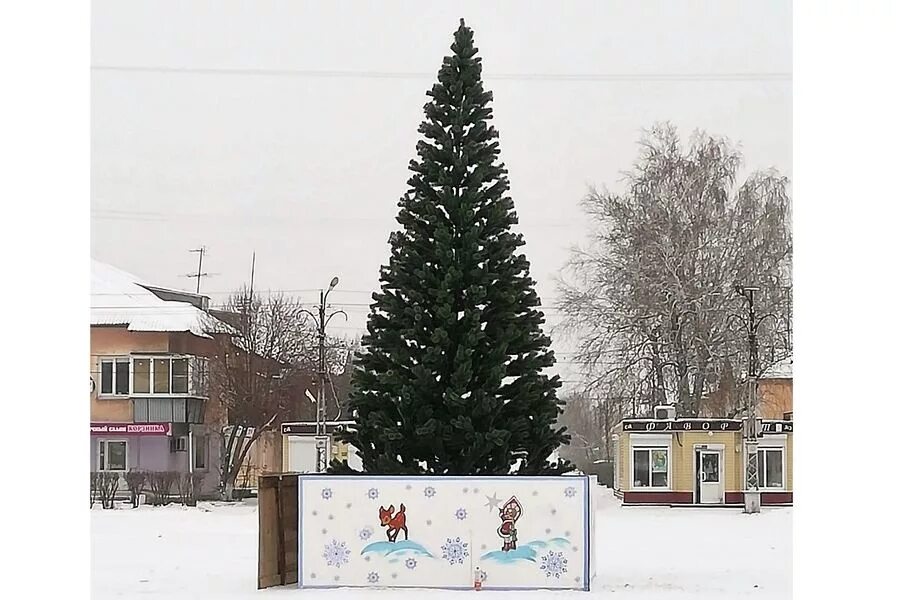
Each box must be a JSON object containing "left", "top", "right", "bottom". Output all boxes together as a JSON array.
[{"left": 91, "top": 488, "right": 792, "bottom": 600}]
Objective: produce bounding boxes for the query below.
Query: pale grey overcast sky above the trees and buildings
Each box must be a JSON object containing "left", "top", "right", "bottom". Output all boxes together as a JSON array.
[{"left": 91, "top": 0, "right": 791, "bottom": 384}]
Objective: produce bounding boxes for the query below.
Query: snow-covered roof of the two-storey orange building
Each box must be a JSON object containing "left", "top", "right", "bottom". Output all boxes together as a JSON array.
[{"left": 91, "top": 259, "right": 210, "bottom": 337}]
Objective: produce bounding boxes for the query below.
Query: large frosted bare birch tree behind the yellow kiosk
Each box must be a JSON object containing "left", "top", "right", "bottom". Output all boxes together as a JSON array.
[{"left": 560, "top": 125, "right": 792, "bottom": 416}]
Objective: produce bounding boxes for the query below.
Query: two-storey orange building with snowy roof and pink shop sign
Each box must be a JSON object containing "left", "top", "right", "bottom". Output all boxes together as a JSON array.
[{"left": 90, "top": 260, "right": 224, "bottom": 495}]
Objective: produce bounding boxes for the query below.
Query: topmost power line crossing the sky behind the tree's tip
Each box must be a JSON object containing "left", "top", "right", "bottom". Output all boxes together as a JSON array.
[{"left": 91, "top": 65, "right": 793, "bottom": 83}]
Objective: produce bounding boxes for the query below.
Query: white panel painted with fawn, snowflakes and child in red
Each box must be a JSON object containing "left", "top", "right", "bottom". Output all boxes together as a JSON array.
[{"left": 299, "top": 475, "right": 593, "bottom": 590}]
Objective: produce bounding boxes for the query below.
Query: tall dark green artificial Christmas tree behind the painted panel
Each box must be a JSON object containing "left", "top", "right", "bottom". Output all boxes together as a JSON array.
[{"left": 336, "top": 21, "right": 570, "bottom": 474}]
